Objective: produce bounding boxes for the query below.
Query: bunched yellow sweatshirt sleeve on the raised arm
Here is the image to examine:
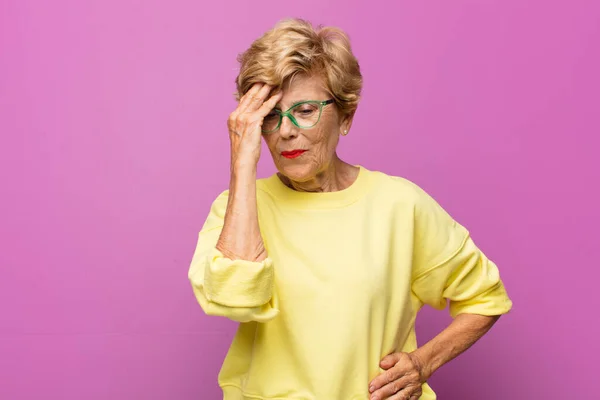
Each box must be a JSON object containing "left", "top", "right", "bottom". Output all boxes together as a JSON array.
[{"left": 188, "top": 191, "right": 279, "bottom": 322}]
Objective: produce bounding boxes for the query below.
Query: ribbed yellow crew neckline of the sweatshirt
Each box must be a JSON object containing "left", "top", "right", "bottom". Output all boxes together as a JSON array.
[{"left": 264, "top": 165, "right": 370, "bottom": 209}]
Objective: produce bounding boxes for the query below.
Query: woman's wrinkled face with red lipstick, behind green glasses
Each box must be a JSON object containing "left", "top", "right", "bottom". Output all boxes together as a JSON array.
[{"left": 263, "top": 75, "right": 351, "bottom": 182}]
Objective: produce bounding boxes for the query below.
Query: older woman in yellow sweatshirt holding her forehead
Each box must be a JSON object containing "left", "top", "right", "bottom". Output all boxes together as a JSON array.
[{"left": 189, "top": 20, "right": 512, "bottom": 400}]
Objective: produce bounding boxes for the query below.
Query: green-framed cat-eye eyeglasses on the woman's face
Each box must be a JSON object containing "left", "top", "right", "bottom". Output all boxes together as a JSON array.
[{"left": 262, "top": 99, "right": 334, "bottom": 133}]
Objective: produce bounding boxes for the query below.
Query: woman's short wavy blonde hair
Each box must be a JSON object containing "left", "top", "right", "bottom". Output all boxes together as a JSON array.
[{"left": 236, "top": 19, "right": 362, "bottom": 115}]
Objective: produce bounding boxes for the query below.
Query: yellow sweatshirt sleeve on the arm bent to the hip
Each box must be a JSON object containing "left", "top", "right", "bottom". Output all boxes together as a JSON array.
[{"left": 412, "top": 184, "right": 512, "bottom": 318}]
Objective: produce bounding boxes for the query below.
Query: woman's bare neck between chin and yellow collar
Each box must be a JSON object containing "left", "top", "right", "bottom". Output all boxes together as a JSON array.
[{"left": 279, "top": 155, "right": 359, "bottom": 192}]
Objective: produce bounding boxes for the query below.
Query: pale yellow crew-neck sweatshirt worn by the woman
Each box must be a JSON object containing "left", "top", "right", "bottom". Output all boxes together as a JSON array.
[{"left": 189, "top": 167, "right": 512, "bottom": 400}]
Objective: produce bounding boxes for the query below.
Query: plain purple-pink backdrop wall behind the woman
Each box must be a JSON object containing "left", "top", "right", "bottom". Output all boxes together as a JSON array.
[{"left": 0, "top": 0, "right": 600, "bottom": 400}]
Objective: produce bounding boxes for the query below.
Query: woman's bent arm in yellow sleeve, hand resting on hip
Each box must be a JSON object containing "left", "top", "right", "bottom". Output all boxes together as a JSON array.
[{"left": 369, "top": 187, "right": 512, "bottom": 400}]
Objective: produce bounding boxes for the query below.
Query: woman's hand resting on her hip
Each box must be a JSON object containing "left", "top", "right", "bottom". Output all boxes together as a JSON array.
[{"left": 369, "top": 353, "right": 426, "bottom": 400}]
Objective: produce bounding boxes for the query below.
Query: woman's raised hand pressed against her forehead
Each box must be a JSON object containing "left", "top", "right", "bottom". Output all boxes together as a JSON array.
[{"left": 227, "top": 83, "right": 282, "bottom": 169}]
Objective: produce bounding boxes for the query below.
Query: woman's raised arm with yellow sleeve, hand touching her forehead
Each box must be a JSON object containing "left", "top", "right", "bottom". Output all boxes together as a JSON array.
[{"left": 188, "top": 85, "right": 280, "bottom": 322}]
